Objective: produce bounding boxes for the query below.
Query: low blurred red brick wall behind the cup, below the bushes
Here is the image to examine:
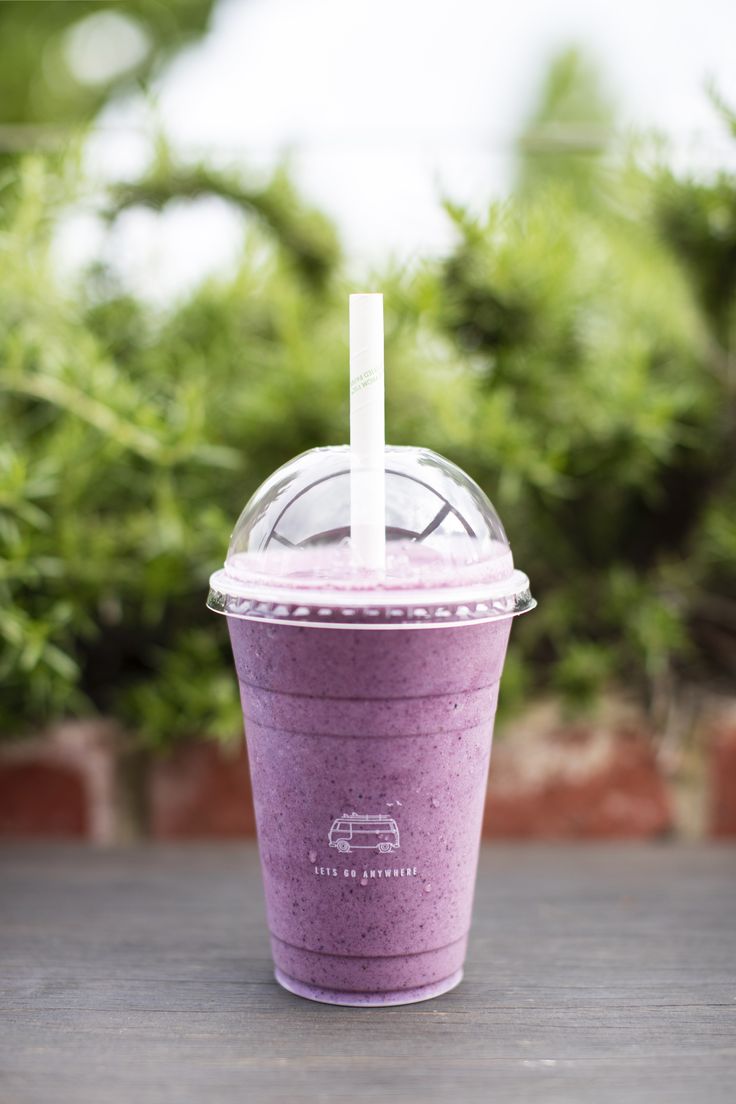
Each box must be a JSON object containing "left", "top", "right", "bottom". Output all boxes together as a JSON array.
[{"left": 0, "top": 701, "right": 736, "bottom": 845}]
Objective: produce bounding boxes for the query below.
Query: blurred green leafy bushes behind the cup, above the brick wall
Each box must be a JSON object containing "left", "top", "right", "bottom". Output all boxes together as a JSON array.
[{"left": 0, "top": 43, "right": 736, "bottom": 746}]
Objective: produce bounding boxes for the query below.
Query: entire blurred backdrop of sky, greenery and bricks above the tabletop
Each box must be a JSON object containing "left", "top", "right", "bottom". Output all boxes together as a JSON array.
[{"left": 0, "top": 0, "right": 736, "bottom": 843}]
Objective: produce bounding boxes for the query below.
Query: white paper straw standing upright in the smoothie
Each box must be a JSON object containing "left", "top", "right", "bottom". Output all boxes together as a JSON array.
[{"left": 350, "top": 295, "right": 386, "bottom": 571}]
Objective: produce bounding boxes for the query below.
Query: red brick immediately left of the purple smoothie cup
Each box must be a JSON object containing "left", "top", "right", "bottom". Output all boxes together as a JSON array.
[{"left": 149, "top": 742, "right": 255, "bottom": 839}]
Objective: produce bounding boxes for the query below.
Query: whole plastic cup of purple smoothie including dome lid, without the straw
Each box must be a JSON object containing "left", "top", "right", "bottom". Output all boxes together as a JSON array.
[{"left": 209, "top": 448, "right": 534, "bottom": 1006}]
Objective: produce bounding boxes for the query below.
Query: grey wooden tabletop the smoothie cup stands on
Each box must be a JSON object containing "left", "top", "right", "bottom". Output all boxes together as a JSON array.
[{"left": 0, "top": 843, "right": 736, "bottom": 1104}]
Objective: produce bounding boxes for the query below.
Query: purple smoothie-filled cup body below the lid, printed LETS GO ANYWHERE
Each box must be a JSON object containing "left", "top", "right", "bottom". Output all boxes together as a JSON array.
[{"left": 227, "top": 617, "right": 511, "bottom": 1005}]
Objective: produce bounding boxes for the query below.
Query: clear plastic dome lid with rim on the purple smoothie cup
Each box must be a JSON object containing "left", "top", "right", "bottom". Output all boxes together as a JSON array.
[{"left": 207, "top": 446, "right": 535, "bottom": 627}]
